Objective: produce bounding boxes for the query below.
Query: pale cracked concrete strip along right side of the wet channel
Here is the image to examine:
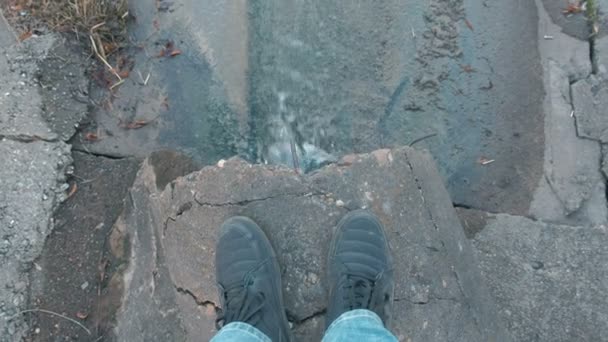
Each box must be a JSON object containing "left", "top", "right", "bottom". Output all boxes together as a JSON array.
[{"left": 529, "top": 0, "right": 608, "bottom": 224}]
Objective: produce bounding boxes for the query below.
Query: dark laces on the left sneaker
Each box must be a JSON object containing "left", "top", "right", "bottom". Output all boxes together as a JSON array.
[{"left": 215, "top": 282, "right": 266, "bottom": 330}]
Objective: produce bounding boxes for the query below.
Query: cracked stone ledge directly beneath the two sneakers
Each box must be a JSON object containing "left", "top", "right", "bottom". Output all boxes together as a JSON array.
[{"left": 114, "top": 148, "right": 508, "bottom": 341}]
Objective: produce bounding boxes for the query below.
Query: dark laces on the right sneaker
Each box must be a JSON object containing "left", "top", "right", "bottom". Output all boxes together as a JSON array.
[{"left": 340, "top": 273, "right": 376, "bottom": 310}]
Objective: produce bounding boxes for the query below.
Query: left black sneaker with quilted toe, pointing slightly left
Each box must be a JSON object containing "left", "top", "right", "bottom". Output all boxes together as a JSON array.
[{"left": 215, "top": 216, "right": 291, "bottom": 342}]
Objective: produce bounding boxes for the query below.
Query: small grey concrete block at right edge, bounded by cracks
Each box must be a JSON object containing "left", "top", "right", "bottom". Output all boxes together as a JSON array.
[{"left": 571, "top": 75, "right": 608, "bottom": 143}]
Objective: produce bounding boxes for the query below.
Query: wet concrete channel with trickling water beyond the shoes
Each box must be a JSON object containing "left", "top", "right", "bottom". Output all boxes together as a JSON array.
[{"left": 74, "top": 0, "right": 543, "bottom": 213}]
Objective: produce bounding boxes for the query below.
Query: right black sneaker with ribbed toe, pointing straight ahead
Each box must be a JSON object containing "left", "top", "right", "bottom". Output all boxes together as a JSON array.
[{"left": 325, "top": 210, "right": 394, "bottom": 327}]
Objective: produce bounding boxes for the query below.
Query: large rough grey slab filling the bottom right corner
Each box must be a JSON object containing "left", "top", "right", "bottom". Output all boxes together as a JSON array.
[{"left": 473, "top": 214, "right": 608, "bottom": 342}]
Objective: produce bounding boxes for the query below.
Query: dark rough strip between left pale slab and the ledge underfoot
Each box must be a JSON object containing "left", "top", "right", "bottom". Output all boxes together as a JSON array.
[{"left": 28, "top": 153, "right": 139, "bottom": 341}]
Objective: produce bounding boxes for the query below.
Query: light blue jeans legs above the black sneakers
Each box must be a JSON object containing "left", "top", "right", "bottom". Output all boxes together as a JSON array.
[{"left": 211, "top": 309, "right": 397, "bottom": 342}]
